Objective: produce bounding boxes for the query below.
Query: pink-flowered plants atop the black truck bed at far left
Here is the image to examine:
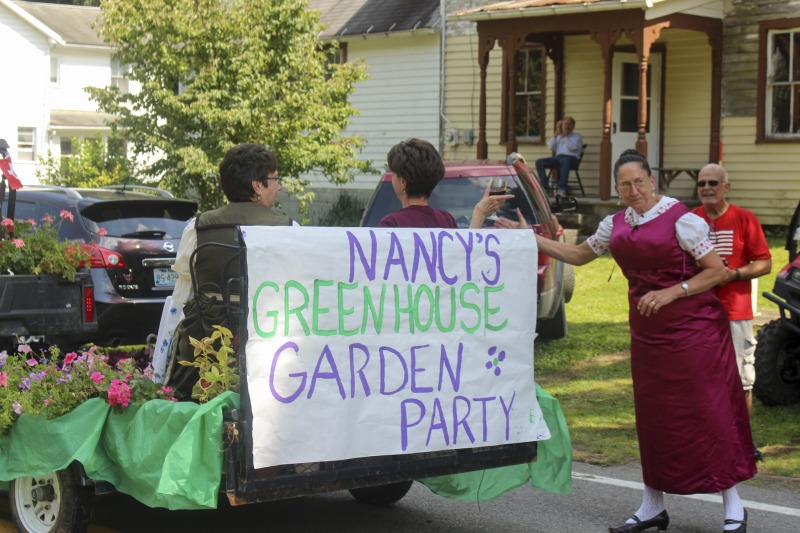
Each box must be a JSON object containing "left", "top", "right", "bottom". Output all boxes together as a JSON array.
[{"left": 0, "top": 211, "right": 91, "bottom": 281}]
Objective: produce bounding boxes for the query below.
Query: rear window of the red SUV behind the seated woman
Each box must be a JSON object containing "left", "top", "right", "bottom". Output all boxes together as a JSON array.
[{"left": 362, "top": 172, "right": 535, "bottom": 228}]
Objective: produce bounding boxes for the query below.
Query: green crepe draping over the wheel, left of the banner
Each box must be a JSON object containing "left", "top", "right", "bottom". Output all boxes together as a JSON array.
[{"left": 0, "top": 392, "right": 239, "bottom": 509}]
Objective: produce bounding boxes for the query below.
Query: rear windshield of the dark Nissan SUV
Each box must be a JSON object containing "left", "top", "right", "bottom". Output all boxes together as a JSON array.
[{"left": 81, "top": 201, "right": 194, "bottom": 239}]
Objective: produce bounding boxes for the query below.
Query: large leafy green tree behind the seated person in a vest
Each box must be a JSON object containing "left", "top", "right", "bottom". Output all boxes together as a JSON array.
[{"left": 87, "top": 0, "right": 369, "bottom": 209}]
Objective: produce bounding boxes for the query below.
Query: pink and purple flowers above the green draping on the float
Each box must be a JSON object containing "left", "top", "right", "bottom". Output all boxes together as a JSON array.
[{"left": 0, "top": 345, "right": 175, "bottom": 436}]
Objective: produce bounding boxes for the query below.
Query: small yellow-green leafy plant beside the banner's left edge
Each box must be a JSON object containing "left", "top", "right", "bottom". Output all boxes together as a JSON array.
[{"left": 178, "top": 326, "right": 239, "bottom": 403}]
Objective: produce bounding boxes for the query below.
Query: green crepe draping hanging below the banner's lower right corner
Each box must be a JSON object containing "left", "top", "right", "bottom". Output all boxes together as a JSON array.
[{"left": 419, "top": 383, "right": 572, "bottom": 502}]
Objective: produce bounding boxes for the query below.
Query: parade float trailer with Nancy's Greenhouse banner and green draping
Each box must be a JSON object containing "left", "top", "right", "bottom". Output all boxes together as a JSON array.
[{"left": 0, "top": 226, "right": 571, "bottom": 533}]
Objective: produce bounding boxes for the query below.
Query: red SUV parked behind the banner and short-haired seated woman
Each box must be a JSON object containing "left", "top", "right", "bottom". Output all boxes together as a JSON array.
[{"left": 361, "top": 154, "right": 575, "bottom": 339}]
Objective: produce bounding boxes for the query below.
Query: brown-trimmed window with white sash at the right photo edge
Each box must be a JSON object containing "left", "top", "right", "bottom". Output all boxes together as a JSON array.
[{"left": 764, "top": 27, "right": 800, "bottom": 139}]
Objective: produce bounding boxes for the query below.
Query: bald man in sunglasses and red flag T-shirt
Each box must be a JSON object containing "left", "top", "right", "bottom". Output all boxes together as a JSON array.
[{"left": 692, "top": 163, "right": 772, "bottom": 457}]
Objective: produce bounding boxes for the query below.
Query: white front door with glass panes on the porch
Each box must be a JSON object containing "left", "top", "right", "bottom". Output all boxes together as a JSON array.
[{"left": 611, "top": 52, "right": 661, "bottom": 190}]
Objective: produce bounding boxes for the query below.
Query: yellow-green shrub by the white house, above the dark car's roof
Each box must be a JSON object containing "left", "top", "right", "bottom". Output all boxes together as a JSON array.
[{"left": 36, "top": 138, "right": 135, "bottom": 188}]
